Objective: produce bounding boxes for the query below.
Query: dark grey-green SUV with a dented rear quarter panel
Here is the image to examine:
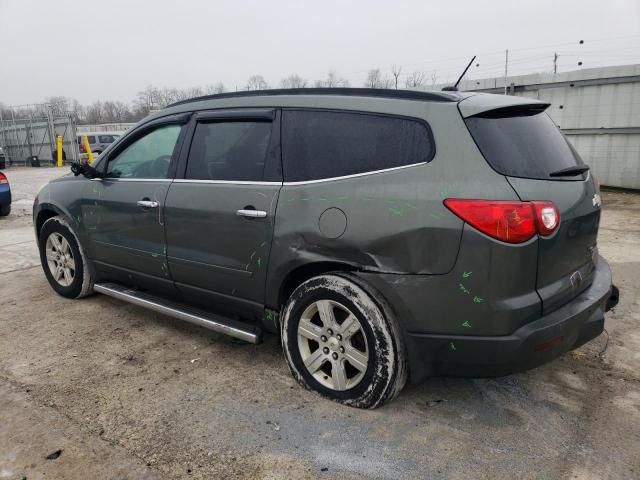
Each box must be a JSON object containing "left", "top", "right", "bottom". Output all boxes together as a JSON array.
[{"left": 34, "top": 89, "right": 617, "bottom": 408}]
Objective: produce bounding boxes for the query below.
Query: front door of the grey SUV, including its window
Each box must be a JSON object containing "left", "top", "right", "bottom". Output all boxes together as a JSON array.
[{"left": 82, "top": 116, "right": 188, "bottom": 284}]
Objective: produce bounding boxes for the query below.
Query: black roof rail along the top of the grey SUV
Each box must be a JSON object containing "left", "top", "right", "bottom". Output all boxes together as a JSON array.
[{"left": 166, "top": 88, "right": 464, "bottom": 108}]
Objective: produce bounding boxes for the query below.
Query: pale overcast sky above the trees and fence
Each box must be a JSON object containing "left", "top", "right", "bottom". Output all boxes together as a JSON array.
[{"left": 0, "top": 0, "right": 640, "bottom": 105}]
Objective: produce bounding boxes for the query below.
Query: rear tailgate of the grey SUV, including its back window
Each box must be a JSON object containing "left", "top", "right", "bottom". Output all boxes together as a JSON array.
[{"left": 465, "top": 104, "right": 600, "bottom": 313}]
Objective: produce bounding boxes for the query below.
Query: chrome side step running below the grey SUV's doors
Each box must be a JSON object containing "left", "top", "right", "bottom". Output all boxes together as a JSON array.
[{"left": 93, "top": 283, "right": 262, "bottom": 343}]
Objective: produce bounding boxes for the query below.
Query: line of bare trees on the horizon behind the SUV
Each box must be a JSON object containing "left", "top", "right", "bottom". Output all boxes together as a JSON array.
[{"left": 0, "top": 69, "right": 436, "bottom": 125}]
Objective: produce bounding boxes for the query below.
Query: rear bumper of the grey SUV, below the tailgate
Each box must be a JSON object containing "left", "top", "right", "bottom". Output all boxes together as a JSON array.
[{"left": 406, "top": 253, "right": 617, "bottom": 382}]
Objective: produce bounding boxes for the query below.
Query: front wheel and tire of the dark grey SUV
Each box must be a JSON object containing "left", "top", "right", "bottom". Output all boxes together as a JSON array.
[{"left": 38, "top": 216, "right": 93, "bottom": 298}]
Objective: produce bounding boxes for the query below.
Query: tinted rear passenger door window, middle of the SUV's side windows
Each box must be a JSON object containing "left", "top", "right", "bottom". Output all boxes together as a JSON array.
[{"left": 185, "top": 122, "right": 272, "bottom": 181}]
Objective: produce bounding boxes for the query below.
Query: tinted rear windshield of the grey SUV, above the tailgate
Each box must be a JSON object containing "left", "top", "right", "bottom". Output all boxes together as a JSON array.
[{"left": 465, "top": 110, "right": 585, "bottom": 180}]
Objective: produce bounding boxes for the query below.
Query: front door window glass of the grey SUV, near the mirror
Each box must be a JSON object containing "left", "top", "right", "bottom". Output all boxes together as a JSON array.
[{"left": 107, "top": 125, "right": 182, "bottom": 178}]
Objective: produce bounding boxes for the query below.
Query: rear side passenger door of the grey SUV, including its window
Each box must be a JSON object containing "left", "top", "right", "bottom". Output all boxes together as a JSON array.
[{"left": 165, "top": 110, "right": 282, "bottom": 311}]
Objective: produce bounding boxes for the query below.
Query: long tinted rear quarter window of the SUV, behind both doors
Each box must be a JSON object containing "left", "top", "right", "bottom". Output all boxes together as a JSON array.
[{"left": 282, "top": 110, "right": 435, "bottom": 182}]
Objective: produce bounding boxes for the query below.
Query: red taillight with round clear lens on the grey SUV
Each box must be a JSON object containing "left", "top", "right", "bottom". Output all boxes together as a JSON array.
[{"left": 444, "top": 198, "right": 560, "bottom": 243}]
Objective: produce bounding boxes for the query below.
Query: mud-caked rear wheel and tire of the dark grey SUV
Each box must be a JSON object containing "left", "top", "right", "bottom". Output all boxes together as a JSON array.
[{"left": 281, "top": 273, "right": 407, "bottom": 408}]
